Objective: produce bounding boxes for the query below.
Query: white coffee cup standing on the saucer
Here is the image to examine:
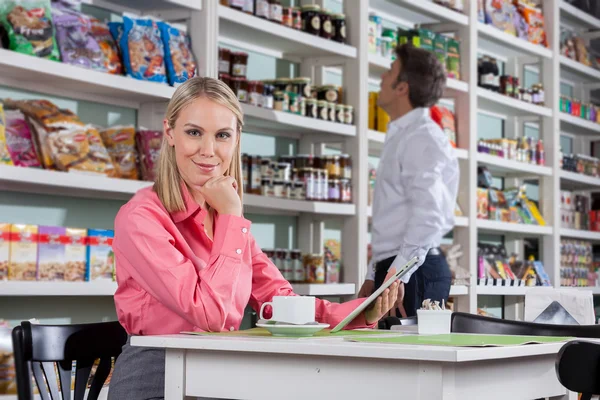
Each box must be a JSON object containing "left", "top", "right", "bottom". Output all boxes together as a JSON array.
[{"left": 259, "top": 296, "right": 315, "bottom": 325}]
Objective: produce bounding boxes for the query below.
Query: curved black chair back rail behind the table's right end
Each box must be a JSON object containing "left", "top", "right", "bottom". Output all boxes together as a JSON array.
[{"left": 450, "top": 312, "right": 600, "bottom": 338}]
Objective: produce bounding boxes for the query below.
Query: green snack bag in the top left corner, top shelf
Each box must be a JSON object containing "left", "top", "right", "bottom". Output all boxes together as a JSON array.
[{"left": 0, "top": 0, "right": 59, "bottom": 60}]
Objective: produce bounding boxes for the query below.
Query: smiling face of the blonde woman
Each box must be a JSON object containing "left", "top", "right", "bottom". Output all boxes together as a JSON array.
[{"left": 163, "top": 97, "right": 239, "bottom": 189}]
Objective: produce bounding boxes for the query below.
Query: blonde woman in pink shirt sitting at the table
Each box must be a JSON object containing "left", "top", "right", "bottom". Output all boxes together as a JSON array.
[{"left": 109, "top": 77, "right": 397, "bottom": 400}]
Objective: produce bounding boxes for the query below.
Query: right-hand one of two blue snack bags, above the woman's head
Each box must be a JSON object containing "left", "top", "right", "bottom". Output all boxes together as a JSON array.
[{"left": 158, "top": 22, "right": 198, "bottom": 86}]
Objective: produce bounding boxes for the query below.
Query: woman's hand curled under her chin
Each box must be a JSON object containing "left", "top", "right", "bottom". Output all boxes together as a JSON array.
[{"left": 199, "top": 176, "right": 242, "bottom": 217}]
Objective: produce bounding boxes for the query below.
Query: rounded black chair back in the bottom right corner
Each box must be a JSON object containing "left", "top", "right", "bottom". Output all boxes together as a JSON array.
[{"left": 556, "top": 340, "right": 600, "bottom": 400}]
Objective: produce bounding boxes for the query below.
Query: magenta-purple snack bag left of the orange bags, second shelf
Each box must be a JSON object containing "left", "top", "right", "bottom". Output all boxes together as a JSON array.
[{"left": 4, "top": 110, "right": 42, "bottom": 168}]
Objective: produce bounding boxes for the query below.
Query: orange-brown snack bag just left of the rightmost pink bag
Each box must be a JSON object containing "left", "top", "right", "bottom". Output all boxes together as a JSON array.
[{"left": 100, "top": 125, "right": 139, "bottom": 180}]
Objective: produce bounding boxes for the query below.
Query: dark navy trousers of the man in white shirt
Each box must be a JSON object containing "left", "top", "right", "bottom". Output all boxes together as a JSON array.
[{"left": 375, "top": 249, "right": 452, "bottom": 317}]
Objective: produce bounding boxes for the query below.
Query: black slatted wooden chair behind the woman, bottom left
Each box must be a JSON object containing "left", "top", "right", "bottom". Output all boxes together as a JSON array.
[{"left": 12, "top": 321, "right": 127, "bottom": 400}]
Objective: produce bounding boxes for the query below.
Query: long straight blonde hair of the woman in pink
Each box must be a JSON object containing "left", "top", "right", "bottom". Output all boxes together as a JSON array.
[{"left": 154, "top": 77, "right": 244, "bottom": 212}]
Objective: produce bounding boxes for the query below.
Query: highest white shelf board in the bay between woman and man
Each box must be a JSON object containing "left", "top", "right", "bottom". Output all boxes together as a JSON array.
[{"left": 219, "top": 6, "right": 357, "bottom": 58}]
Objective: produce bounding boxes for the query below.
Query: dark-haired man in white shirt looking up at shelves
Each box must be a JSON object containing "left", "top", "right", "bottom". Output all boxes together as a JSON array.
[{"left": 359, "top": 45, "right": 459, "bottom": 317}]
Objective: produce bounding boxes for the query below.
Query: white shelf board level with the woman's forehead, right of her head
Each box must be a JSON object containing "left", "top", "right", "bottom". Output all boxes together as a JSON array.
[{"left": 242, "top": 104, "right": 356, "bottom": 141}]
